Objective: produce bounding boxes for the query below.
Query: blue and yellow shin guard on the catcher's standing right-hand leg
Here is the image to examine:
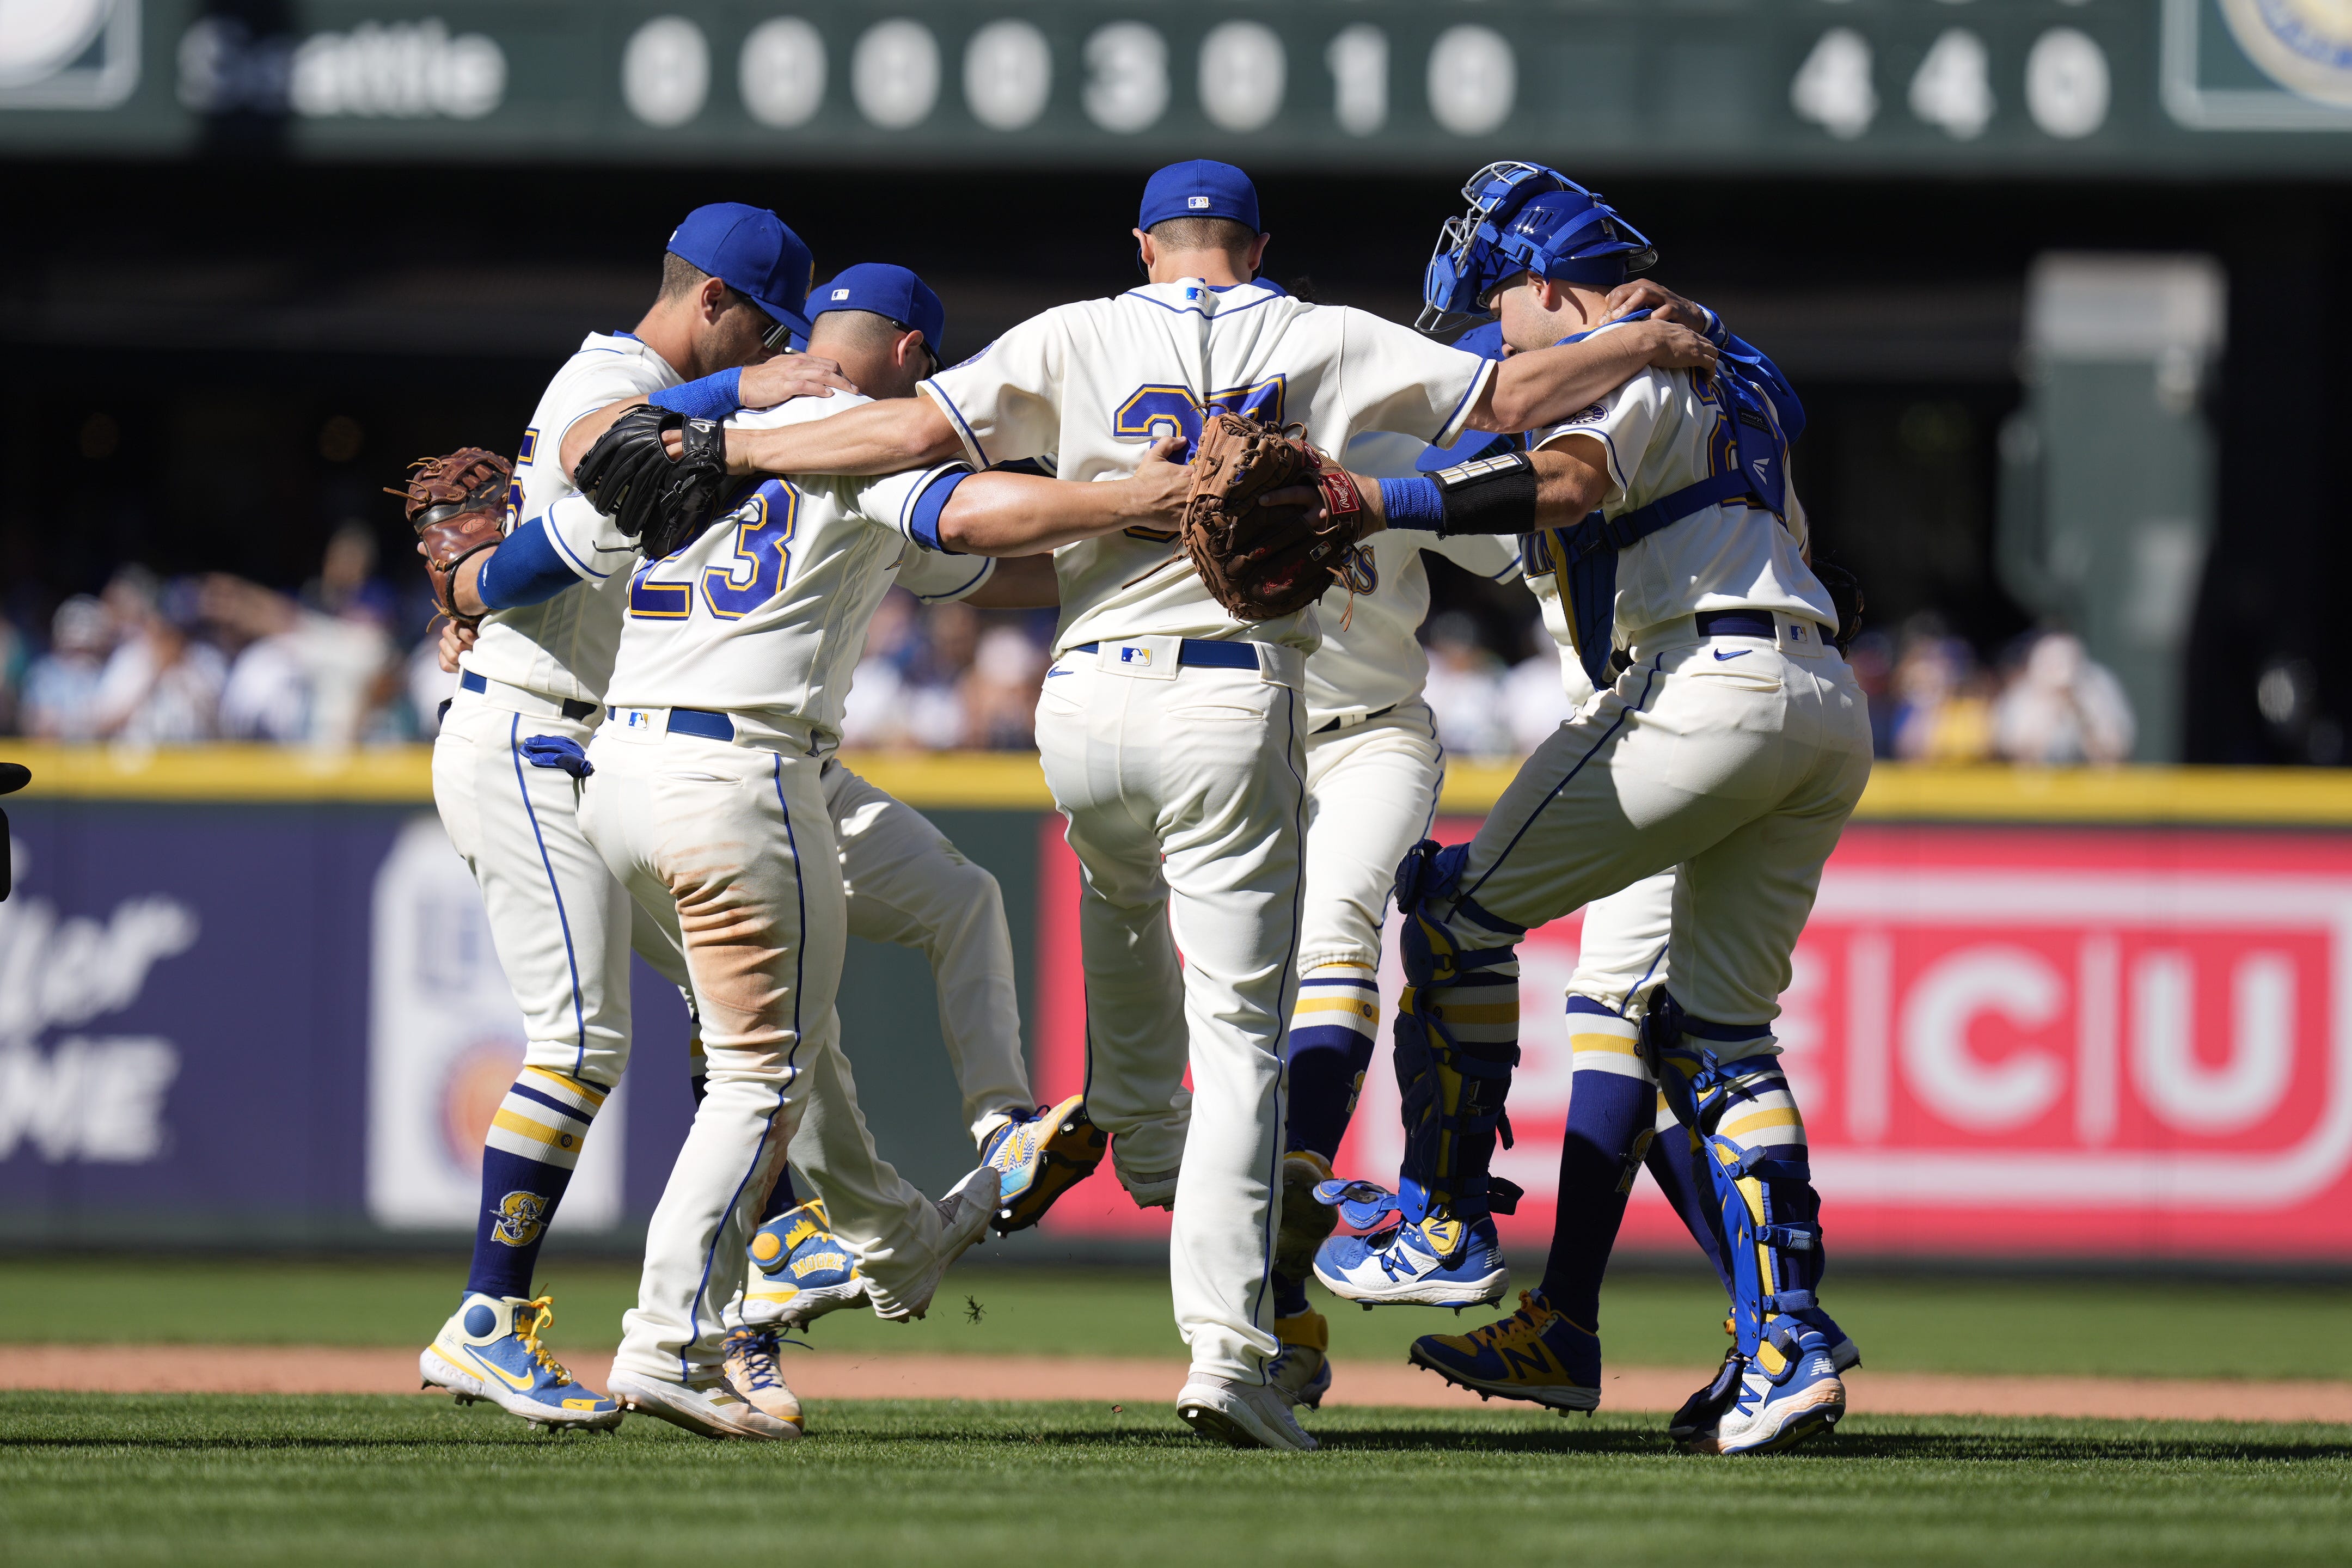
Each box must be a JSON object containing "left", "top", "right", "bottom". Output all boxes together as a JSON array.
[{"left": 1644, "top": 990, "right": 1823, "bottom": 1373}]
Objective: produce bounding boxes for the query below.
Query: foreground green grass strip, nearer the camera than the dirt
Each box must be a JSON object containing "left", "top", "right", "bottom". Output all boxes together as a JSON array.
[{"left": 0, "top": 1394, "right": 2352, "bottom": 1568}]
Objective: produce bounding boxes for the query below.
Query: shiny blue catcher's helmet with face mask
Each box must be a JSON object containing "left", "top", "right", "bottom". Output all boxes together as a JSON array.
[{"left": 1413, "top": 162, "right": 1658, "bottom": 336}]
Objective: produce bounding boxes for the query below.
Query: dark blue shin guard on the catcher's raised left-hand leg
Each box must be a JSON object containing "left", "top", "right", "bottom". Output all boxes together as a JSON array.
[{"left": 1395, "top": 839, "right": 1524, "bottom": 1239}]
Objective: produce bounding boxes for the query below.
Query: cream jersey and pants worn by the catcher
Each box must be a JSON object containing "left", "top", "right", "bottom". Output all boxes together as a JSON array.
[{"left": 1437, "top": 327, "right": 1870, "bottom": 1056}]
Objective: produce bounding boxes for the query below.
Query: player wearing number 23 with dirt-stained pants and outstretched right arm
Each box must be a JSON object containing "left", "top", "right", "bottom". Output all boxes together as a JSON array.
[{"left": 564, "top": 263, "right": 1188, "bottom": 1436}]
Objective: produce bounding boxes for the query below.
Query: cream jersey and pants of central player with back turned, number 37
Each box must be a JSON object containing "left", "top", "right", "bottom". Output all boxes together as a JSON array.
[{"left": 922, "top": 280, "right": 1491, "bottom": 1382}]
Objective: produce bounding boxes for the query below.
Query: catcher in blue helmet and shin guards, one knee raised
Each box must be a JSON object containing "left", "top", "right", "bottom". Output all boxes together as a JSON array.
[{"left": 1317, "top": 164, "right": 1870, "bottom": 1453}]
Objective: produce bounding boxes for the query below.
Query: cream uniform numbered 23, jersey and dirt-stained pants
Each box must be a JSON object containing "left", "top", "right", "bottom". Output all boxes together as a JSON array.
[{"left": 581, "top": 397, "right": 988, "bottom": 1382}]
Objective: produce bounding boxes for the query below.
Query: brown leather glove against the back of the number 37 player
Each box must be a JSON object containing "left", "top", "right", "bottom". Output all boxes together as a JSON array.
[{"left": 1183, "top": 414, "right": 1364, "bottom": 621}]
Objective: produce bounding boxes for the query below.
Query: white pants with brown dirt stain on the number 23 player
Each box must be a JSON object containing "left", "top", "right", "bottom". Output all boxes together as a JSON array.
[{"left": 581, "top": 726, "right": 941, "bottom": 1382}]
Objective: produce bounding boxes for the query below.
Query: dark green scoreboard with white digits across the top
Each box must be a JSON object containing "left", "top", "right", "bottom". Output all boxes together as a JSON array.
[{"left": 14, "top": 0, "right": 2352, "bottom": 179}]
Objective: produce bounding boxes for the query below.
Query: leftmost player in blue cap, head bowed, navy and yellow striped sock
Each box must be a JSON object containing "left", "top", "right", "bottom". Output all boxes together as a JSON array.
[{"left": 419, "top": 205, "right": 865, "bottom": 1427}]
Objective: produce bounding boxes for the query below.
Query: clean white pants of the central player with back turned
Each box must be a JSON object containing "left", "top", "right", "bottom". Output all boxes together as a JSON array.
[{"left": 1037, "top": 637, "right": 1306, "bottom": 1382}]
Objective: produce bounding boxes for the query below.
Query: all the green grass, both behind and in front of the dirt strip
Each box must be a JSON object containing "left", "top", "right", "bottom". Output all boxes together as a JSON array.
[{"left": 0, "top": 1258, "right": 2352, "bottom": 1568}]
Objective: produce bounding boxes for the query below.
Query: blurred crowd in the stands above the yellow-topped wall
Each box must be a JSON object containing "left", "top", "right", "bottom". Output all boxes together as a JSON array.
[{"left": 0, "top": 534, "right": 2133, "bottom": 764}]
